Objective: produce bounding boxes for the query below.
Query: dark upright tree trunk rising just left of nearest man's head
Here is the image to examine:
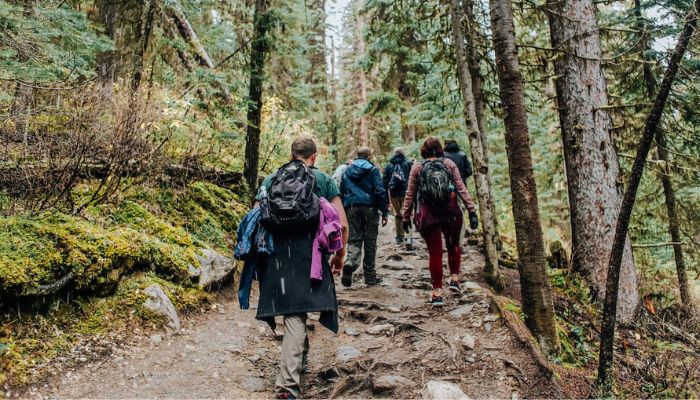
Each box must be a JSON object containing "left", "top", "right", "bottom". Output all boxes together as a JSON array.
[{"left": 243, "top": 0, "right": 269, "bottom": 195}]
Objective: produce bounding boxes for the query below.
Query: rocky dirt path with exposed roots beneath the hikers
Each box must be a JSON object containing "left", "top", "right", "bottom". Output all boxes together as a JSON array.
[{"left": 33, "top": 220, "right": 554, "bottom": 399}]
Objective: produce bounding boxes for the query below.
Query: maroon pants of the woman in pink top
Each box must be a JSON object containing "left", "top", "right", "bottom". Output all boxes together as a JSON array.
[{"left": 421, "top": 215, "right": 462, "bottom": 289}]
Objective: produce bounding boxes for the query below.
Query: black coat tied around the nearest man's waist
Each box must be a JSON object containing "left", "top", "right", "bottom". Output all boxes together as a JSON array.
[{"left": 255, "top": 231, "right": 338, "bottom": 333}]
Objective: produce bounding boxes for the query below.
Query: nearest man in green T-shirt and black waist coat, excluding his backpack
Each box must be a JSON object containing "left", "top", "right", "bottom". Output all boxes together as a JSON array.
[{"left": 256, "top": 137, "right": 348, "bottom": 399}]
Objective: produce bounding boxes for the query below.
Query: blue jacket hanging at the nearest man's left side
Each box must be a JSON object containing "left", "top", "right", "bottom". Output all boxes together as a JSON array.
[{"left": 233, "top": 207, "right": 274, "bottom": 310}]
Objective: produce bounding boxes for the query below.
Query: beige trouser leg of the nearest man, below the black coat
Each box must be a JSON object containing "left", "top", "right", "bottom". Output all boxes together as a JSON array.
[{"left": 275, "top": 314, "right": 306, "bottom": 397}]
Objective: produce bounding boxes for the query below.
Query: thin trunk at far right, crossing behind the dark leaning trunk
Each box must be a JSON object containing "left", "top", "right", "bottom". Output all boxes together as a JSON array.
[{"left": 634, "top": 0, "right": 694, "bottom": 314}]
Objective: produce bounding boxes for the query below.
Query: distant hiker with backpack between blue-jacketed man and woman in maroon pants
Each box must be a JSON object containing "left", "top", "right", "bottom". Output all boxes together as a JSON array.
[{"left": 382, "top": 147, "right": 413, "bottom": 244}]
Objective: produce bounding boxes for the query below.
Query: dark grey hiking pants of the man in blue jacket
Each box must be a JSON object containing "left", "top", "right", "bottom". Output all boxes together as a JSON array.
[{"left": 344, "top": 207, "right": 379, "bottom": 283}]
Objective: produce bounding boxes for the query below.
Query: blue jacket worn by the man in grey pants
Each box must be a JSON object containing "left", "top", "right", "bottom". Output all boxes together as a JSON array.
[{"left": 340, "top": 158, "right": 389, "bottom": 216}]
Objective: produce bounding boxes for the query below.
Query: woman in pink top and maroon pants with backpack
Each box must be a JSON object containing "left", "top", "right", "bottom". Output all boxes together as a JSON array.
[{"left": 401, "top": 137, "right": 478, "bottom": 306}]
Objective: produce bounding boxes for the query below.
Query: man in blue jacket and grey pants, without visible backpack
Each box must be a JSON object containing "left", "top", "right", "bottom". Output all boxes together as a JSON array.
[{"left": 340, "top": 146, "right": 389, "bottom": 287}]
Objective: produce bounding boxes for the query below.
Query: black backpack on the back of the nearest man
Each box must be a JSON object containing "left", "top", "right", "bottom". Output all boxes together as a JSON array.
[{"left": 260, "top": 160, "right": 321, "bottom": 231}]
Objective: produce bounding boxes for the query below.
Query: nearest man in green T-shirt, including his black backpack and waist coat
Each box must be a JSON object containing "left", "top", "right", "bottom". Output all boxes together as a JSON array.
[{"left": 256, "top": 137, "right": 348, "bottom": 399}]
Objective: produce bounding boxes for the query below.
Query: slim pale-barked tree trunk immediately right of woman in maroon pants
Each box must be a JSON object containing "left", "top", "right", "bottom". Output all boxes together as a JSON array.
[{"left": 450, "top": 0, "right": 501, "bottom": 289}]
